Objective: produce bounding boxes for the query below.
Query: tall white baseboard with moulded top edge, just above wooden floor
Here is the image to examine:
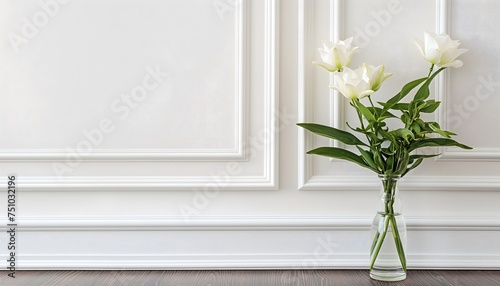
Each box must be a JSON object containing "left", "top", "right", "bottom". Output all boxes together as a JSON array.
[{"left": 0, "top": 216, "right": 500, "bottom": 270}]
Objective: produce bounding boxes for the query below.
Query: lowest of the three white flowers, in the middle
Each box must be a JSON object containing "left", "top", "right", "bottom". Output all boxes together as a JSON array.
[{"left": 330, "top": 67, "right": 375, "bottom": 99}]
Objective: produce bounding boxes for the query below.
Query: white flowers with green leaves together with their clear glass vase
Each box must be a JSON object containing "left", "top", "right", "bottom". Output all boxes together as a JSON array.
[{"left": 298, "top": 32, "right": 472, "bottom": 281}]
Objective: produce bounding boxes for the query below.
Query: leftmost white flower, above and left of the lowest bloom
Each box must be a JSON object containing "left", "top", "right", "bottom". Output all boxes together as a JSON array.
[{"left": 313, "top": 37, "right": 359, "bottom": 72}]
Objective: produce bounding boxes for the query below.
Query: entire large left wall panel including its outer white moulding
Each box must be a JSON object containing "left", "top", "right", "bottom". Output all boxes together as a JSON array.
[{"left": 0, "top": 0, "right": 277, "bottom": 191}]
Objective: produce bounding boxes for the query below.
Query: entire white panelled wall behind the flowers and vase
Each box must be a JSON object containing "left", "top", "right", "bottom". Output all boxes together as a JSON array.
[{"left": 0, "top": 0, "right": 500, "bottom": 269}]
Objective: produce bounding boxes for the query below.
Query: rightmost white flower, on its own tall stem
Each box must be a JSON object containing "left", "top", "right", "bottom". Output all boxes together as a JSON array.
[{"left": 415, "top": 32, "right": 468, "bottom": 68}]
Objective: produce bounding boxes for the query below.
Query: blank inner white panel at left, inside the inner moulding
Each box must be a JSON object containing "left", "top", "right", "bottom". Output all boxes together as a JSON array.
[{"left": 0, "top": 0, "right": 248, "bottom": 160}]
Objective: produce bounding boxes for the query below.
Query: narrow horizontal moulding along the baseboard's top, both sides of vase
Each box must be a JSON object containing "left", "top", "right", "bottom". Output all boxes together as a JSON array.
[{"left": 4, "top": 215, "right": 500, "bottom": 232}]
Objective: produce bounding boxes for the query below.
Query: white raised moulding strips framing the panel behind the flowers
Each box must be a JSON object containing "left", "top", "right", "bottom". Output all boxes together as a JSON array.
[{"left": 298, "top": 0, "right": 500, "bottom": 191}]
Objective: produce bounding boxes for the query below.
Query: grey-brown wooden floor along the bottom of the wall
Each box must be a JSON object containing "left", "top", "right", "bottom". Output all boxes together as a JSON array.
[{"left": 0, "top": 270, "right": 500, "bottom": 286}]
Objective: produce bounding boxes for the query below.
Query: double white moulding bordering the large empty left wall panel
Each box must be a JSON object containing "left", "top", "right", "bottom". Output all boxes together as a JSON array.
[{"left": 0, "top": 0, "right": 279, "bottom": 192}]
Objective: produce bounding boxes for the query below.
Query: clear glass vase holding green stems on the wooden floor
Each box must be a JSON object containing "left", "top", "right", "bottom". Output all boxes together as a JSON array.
[{"left": 370, "top": 175, "right": 406, "bottom": 281}]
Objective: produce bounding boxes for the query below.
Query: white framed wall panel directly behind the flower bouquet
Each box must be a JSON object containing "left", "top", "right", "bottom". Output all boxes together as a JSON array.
[{"left": 298, "top": 0, "right": 500, "bottom": 191}]
